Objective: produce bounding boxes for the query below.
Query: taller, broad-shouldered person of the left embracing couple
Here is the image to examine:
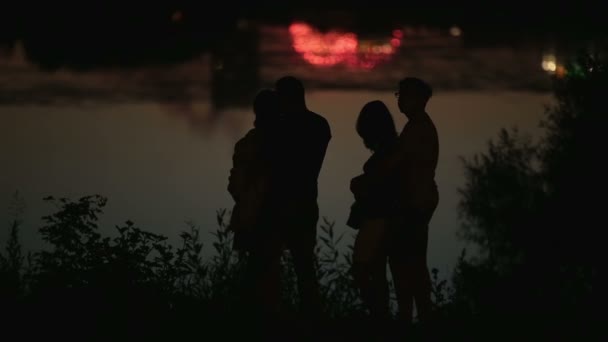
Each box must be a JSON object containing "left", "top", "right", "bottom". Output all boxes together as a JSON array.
[{"left": 271, "top": 76, "right": 331, "bottom": 318}]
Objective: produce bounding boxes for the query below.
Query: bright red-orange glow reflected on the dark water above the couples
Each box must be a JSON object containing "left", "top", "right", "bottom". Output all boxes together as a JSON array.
[{"left": 289, "top": 22, "right": 403, "bottom": 69}]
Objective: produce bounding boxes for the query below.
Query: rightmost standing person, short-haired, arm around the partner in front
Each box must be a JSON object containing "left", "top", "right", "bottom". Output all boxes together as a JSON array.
[{"left": 351, "top": 77, "right": 439, "bottom": 323}]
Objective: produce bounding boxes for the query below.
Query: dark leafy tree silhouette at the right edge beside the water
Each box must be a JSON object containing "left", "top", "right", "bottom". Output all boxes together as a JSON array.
[{"left": 452, "top": 54, "right": 608, "bottom": 338}]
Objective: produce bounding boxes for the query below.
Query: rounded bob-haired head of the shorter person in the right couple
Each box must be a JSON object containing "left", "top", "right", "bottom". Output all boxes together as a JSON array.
[{"left": 357, "top": 100, "right": 397, "bottom": 151}]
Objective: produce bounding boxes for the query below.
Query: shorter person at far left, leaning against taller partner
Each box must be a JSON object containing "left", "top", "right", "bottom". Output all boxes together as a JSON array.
[{"left": 228, "top": 89, "right": 279, "bottom": 314}]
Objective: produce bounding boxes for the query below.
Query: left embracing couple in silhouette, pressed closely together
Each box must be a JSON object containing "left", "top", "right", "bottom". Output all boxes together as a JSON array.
[{"left": 228, "top": 76, "right": 331, "bottom": 318}]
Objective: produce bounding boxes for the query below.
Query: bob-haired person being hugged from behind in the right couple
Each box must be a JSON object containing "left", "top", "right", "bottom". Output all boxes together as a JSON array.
[{"left": 347, "top": 101, "right": 398, "bottom": 320}]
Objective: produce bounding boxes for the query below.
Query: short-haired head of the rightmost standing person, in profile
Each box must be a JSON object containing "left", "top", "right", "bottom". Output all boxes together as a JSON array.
[{"left": 395, "top": 77, "right": 433, "bottom": 117}]
